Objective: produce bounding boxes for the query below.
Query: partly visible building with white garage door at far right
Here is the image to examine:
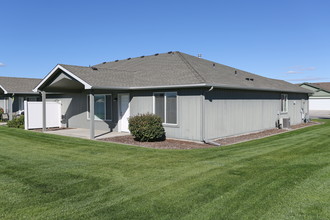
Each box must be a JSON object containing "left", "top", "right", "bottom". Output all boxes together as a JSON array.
[{"left": 300, "top": 82, "right": 330, "bottom": 111}]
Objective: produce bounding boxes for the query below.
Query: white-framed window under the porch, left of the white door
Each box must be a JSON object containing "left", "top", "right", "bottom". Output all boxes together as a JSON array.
[{"left": 87, "top": 94, "right": 112, "bottom": 121}]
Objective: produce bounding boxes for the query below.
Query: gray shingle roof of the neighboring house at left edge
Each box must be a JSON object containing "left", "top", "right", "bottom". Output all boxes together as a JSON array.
[{"left": 0, "top": 76, "right": 41, "bottom": 94}]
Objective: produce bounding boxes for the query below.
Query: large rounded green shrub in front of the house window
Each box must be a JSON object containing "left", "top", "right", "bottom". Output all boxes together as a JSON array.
[{"left": 128, "top": 113, "right": 165, "bottom": 141}]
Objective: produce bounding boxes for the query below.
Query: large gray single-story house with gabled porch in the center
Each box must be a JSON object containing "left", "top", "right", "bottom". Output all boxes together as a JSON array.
[{"left": 34, "top": 52, "right": 310, "bottom": 141}]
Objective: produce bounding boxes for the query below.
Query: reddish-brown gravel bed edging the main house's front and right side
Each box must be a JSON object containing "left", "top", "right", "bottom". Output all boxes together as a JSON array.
[{"left": 99, "top": 122, "right": 321, "bottom": 150}]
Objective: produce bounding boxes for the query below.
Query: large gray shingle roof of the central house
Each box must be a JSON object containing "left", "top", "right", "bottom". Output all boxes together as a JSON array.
[{"left": 55, "top": 52, "right": 310, "bottom": 93}]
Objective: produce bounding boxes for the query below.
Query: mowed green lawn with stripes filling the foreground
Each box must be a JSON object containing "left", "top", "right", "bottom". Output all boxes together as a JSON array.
[{"left": 0, "top": 120, "right": 330, "bottom": 220}]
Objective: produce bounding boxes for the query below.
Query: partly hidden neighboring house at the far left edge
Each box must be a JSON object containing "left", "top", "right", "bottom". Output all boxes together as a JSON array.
[{"left": 0, "top": 77, "right": 41, "bottom": 120}]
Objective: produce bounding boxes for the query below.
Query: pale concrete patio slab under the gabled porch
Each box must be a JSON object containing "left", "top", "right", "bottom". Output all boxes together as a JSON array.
[{"left": 45, "top": 128, "right": 130, "bottom": 139}]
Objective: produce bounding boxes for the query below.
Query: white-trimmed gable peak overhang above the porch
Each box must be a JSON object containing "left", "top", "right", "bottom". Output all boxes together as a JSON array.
[{"left": 33, "top": 64, "right": 92, "bottom": 92}]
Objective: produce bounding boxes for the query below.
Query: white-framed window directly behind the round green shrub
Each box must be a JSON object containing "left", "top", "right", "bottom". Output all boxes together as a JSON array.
[{"left": 153, "top": 92, "right": 178, "bottom": 125}]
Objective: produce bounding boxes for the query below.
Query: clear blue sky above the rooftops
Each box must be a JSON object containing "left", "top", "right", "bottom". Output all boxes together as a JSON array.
[{"left": 0, "top": 0, "right": 330, "bottom": 83}]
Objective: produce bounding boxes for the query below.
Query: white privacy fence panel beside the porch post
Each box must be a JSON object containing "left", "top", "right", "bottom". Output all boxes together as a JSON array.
[{"left": 24, "top": 101, "right": 61, "bottom": 130}]
